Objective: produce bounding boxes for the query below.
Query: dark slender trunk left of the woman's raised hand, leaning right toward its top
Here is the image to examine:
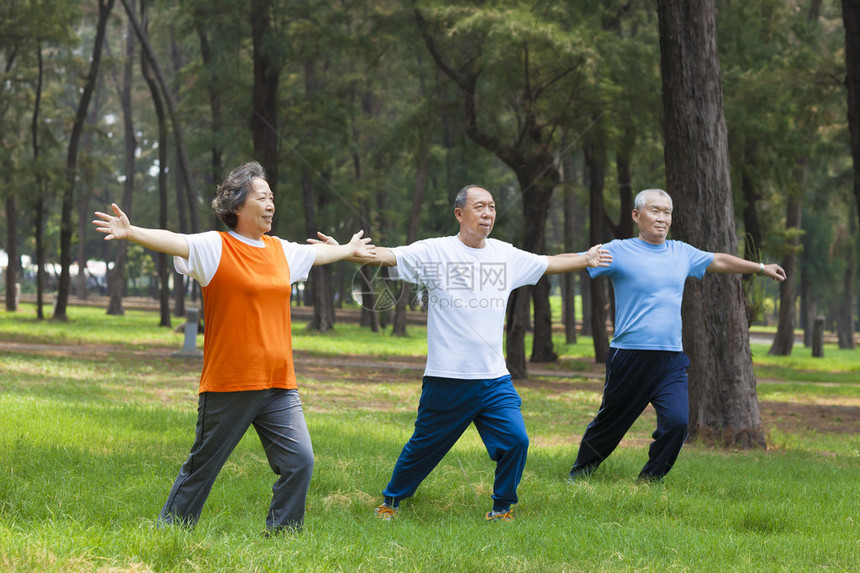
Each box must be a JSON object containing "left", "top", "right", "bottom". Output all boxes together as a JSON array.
[{"left": 53, "top": 0, "right": 114, "bottom": 321}]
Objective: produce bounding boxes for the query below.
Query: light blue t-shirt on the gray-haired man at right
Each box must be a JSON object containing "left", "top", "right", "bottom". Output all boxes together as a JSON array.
[{"left": 588, "top": 238, "right": 714, "bottom": 352}]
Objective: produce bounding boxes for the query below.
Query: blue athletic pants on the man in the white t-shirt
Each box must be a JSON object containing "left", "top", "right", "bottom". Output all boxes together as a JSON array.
[{"left": 382, "top": 376, "right": 529, "bottom": 511}]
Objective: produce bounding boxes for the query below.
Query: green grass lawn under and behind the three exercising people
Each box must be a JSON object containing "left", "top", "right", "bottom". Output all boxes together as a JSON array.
[{"left": 0, "top": 305, "right": 860, "bottom": 572}]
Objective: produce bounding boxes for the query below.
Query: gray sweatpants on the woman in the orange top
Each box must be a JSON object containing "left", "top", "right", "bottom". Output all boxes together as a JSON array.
[{"left": 159, "top": 388, "right": 314, "bottom": 530}]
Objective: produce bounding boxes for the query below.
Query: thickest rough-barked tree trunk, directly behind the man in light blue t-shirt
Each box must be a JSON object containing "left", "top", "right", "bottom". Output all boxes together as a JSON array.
[{"left": 657, "top": 0, "right": 765, "bottom": 447}]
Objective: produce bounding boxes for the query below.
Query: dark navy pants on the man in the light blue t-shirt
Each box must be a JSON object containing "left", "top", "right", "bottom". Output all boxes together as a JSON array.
[{"left": 570, "top": 348, "right": 690, "bottom": 479}]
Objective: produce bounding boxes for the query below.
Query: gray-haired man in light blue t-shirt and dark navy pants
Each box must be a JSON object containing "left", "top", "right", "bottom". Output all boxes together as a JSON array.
[{"left": 568, "top": 189, "right": 785, "bottom": 481}]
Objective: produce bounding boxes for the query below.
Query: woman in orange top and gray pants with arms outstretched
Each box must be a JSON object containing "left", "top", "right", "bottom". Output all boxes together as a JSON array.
[{"left": 93, "top": 162, "right": 375, "bottom": 534}]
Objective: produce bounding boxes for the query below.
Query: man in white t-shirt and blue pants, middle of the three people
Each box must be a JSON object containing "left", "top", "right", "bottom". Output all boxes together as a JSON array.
[{"left": 320, "top": 185, "right": 612, "bottom": 521}]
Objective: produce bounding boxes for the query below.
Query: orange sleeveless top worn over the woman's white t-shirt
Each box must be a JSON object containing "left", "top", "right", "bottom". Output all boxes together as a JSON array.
[{"left": 199, "top": 233, "right": 296, "bottom": 393}]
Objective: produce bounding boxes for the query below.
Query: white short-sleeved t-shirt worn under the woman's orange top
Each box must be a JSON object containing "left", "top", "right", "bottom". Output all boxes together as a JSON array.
[{"left": 173, "top": 231, "right": 316, "bottom": 286}]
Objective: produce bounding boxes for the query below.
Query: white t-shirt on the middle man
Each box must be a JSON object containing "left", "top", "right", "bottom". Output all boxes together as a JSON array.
[{"left": 391, "top": 236, "right": 547, "bottom": 380}]
